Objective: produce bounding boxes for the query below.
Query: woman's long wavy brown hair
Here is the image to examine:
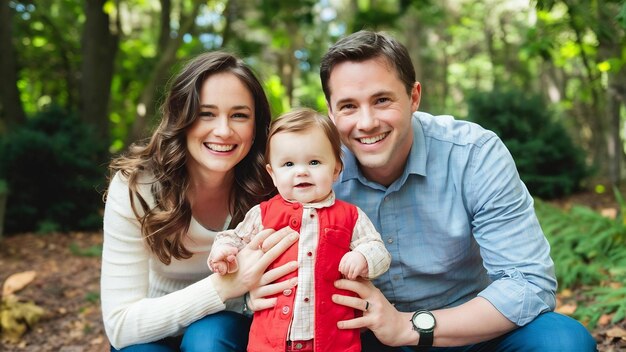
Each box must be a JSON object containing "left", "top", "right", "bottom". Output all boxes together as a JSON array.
[{"left": 109, "top": 52, "right": 275, "bottom": 264}]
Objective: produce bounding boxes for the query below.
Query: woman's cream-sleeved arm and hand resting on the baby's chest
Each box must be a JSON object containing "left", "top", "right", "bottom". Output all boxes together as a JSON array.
[{"left": 101, "top": 175, "right": 297, "bottom": 348}]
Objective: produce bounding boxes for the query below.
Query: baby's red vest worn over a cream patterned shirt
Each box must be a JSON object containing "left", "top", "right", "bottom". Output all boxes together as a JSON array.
[{"left": 248, "top": 195, "right": 361, "bottom": 352}]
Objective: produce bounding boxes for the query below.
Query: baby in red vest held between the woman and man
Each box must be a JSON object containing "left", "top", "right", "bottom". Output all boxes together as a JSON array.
[{"left": 208, "top": 109, "right": 391, "bottom": 351}]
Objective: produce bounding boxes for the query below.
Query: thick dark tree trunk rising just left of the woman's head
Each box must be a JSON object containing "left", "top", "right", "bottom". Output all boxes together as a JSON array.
[{"left": 79, "top": 0, "right": 119, "bottom": 143}]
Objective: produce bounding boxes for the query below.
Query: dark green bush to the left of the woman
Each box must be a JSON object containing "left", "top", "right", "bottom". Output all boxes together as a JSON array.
[{"left": 0, "top": 108, "right": 105, "bottom": 233}]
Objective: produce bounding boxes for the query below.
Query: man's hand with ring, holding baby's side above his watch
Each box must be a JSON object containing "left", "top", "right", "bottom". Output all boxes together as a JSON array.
[{"left": 333, "top": 279, "right": 418, "bottom": 346}]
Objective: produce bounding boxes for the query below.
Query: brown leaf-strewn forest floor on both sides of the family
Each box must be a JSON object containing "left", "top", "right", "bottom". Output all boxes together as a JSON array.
[{"left": 0, "top": 192, "right": 626, "bottom": 352}]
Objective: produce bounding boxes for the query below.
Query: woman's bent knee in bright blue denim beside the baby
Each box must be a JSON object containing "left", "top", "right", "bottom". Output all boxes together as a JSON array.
[{"left": 180, "top": 311, "right": 252, "bottom": 352}]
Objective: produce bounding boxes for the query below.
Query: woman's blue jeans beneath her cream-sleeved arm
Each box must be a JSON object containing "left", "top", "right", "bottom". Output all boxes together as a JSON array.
[{"left": 111, "top": 311, "right": 252, "bottom": 352}]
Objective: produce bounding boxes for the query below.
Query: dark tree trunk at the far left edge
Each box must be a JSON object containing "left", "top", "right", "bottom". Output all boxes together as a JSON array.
[{"left": 0, "top": 0, "right": 26, "bottom": 135}]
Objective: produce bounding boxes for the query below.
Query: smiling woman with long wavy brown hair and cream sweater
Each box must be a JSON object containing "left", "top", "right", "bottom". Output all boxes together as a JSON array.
[{"left": 101, "top": 52, "right": 297, "bottom": 351}]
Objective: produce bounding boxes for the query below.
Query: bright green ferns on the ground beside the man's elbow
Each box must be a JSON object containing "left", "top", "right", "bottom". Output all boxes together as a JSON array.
[{"left": 535, "top": 196, "right": 626, "bottom": 328}]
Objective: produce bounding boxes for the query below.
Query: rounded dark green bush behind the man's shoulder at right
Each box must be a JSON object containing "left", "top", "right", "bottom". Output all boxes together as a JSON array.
[{"left": 468, "top": 89, "right": 590, "bottom": 199}]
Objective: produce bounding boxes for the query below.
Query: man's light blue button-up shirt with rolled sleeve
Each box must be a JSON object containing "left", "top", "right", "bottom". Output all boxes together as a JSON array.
[{"left": 335, "top": 112, "right": 557, "bottom": 326}]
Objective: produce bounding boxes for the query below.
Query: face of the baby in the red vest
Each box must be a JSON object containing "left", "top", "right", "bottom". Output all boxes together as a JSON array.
[{"left": 267, "top": 128, "right": 340, "bottom": 203}]
